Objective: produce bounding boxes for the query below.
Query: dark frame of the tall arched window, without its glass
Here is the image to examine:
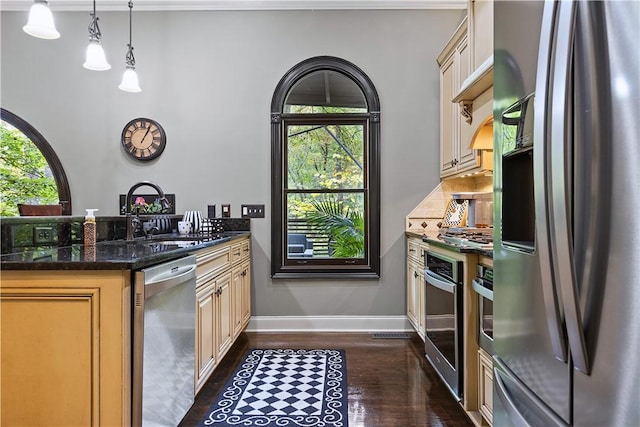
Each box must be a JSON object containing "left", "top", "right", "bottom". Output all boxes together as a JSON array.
[{"left": 271, "top": 56, "right": 380, "bottom": 279}]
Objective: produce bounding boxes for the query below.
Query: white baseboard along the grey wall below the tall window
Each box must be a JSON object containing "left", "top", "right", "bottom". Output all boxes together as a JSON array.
[{"left": 246, "top": 316, "right": 414, "bottom": 333}]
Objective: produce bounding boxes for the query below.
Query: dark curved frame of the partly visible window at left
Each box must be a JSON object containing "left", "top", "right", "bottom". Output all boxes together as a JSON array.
[{"left": 0, "top": 108, "right": 73, "bottom": 215}]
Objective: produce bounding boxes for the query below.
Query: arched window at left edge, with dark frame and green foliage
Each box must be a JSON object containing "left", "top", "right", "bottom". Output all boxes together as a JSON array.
[{"left": 0, "top": 108, "right": 72, "bottom": 216}]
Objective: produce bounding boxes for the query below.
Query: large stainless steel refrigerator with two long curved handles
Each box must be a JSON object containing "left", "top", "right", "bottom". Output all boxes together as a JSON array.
[{"left": 493, "top": 0, "right": 640, "bottom": 427}]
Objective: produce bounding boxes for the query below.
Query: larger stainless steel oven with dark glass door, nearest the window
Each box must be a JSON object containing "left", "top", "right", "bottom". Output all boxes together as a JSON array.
[{"left": 424, "top": 250, "right": 463, "bottom": 400}]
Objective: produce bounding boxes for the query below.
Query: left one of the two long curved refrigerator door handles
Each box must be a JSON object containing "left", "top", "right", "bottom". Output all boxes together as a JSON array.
[{"left": 529, "top": 1, "right": 568, "bottom": 362}]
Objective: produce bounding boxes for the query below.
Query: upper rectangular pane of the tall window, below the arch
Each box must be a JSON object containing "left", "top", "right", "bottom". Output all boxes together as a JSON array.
[{"left": 287, "top": 125, "right": 364, "bottom": 190}]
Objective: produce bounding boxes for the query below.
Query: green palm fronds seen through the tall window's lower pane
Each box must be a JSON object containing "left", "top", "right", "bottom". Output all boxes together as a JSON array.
[{"left": 307, "top": 199, "right": 364, "bottom": 258}]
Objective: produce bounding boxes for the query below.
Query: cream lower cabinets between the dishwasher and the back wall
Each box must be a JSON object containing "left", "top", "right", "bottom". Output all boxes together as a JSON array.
[{"left": 195, "top": 237, "right": 251, "bottom": 393}]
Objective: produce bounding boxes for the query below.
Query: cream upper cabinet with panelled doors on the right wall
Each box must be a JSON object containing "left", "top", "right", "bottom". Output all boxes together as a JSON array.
[{"left": 438, "top": 18, "right": 478, "bottom": 177}]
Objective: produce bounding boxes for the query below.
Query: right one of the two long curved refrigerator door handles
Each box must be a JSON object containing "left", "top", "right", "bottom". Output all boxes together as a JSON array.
[{"left": 550, "top": 1, "right": 589, "bottom": 374}]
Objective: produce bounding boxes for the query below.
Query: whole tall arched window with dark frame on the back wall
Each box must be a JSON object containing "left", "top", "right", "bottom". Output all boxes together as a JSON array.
[{"left": 271, "top": 56, "right": 380, "bottom": 278}]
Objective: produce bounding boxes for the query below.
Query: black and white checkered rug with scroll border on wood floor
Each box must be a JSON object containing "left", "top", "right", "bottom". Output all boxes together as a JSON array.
[{"left": 198, "top": 349, "right": 349, "bottom": 427}]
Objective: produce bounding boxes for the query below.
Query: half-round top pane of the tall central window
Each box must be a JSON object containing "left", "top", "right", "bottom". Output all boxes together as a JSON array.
[{"left": 284, "top": 70, "right": 367, "bottom": 113}]
